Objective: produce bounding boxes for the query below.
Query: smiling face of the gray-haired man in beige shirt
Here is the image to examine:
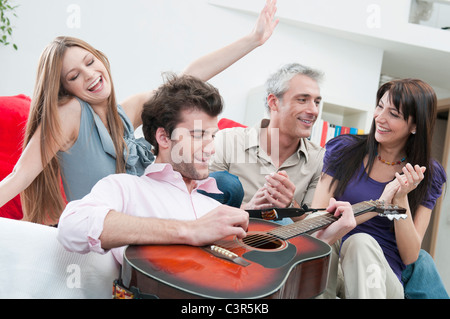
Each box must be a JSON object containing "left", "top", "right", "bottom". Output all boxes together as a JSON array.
[{"left": 269, "top": 74, "right": 322, "bottom": 138}]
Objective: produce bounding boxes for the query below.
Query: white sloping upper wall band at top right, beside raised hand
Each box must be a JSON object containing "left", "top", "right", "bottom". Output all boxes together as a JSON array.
[{"left": 214, "top": 0, "right": 450, "bottom": 52}]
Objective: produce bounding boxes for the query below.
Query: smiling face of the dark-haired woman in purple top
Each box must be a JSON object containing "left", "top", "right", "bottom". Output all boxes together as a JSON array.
[{"left": 374, "top": 92, "right": 416, "bottom": 147}]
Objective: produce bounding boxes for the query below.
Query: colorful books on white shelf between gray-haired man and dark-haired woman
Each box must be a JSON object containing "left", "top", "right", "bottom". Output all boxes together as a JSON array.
[{"left": 309, "top": 119, "right": 364, "bottom": 147}]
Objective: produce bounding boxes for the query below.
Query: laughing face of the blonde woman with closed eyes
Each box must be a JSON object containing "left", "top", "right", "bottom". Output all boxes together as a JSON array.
[{"left": 61, "top": 46, "right": 111, "bottom": 105}]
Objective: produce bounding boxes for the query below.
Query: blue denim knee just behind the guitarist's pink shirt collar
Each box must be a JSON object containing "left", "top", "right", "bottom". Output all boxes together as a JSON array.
[{"left": 198, "top": 171, "right": 244, "bottom": 208}]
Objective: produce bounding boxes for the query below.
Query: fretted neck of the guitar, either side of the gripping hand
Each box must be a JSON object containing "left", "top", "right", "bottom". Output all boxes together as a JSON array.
[{"left": 269, "top": 202, "right": 376, "bottom": 240}]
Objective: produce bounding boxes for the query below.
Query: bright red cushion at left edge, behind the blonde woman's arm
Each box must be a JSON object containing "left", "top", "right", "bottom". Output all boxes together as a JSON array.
[{"left": 0, "top": 94, "right": 31, "bottom": 219}]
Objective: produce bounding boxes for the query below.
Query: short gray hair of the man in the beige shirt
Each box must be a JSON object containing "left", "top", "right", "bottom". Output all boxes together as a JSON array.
[{"left": 265, "top": 63, "right": 324, "bottom": 110}]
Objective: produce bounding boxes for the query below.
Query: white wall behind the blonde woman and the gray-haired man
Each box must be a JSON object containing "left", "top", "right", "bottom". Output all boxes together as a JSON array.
[{"left": 0, "top": 0, "right": 382, "bottom": 124}]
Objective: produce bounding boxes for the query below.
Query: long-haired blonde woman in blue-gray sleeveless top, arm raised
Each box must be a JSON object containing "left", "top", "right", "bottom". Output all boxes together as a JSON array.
[{"left": 0, "top": 0, "right": 278, "bottom": 224}]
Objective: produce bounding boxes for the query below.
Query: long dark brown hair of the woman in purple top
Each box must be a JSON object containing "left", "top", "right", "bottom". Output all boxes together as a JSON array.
[{"left": 325, "top": 79, "right": 437, "bottom": 216}]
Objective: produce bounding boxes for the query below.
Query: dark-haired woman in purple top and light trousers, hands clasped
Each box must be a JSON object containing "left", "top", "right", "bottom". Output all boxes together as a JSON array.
[{"left": 313, "top": 79, "right": 446, "bottom": 298}]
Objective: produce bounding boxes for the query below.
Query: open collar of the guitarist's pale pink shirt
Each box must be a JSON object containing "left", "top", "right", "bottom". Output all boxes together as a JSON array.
[{"left": 144, "top": 163, "right": 222, "bottom": 194}]
